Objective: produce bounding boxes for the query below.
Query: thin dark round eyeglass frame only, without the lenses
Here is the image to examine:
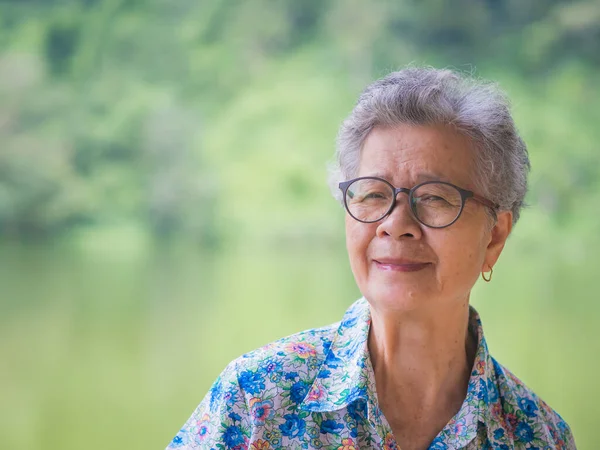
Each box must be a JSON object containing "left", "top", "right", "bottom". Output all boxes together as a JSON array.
[{"left": 338, "top": 177, "right": 499, "bottom": 229}]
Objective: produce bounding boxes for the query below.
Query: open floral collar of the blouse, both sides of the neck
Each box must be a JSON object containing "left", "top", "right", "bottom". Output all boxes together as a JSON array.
[{"left": 300, "top": 297, "right": 512, "bottom": 447}]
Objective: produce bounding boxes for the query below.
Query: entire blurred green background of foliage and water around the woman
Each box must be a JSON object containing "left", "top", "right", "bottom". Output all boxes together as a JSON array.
[{"left": 0, "top": 0, "right": 600, "bottom": 450}]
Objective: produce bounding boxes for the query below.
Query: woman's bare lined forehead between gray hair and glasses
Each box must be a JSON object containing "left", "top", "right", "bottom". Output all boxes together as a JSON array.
[{"left": 358, "top": 124, "right": 473, "bottom": 189}]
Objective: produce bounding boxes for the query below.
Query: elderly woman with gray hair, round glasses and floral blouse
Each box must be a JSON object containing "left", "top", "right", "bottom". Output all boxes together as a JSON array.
[{"left": 169, "top": 68, "right": 575, "bottom": 450}]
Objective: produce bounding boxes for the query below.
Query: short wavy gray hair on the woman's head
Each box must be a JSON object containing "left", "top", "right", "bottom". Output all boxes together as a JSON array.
[{"left": 329, "top": 67, "right": 530, "bottom": 225}]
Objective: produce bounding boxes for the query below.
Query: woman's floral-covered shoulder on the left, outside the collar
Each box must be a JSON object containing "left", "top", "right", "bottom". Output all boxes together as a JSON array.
[{"left": 169, "top": 324, "right": 339, "bottom": 449}]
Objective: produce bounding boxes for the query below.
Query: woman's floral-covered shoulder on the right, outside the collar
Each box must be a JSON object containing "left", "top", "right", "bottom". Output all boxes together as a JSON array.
[{"left": 493, "top": 359, "right": 575, "bottom": 449}]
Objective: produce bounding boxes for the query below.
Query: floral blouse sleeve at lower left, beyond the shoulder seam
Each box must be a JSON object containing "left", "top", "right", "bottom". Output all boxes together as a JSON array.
[{"left": 167, "top": 362, "right": 252, "bottom": 450}]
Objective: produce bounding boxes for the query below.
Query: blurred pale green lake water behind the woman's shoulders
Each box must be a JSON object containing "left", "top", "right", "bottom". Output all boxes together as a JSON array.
[{"left": 0, "top": 236, "right": 600, "bottom": 450}]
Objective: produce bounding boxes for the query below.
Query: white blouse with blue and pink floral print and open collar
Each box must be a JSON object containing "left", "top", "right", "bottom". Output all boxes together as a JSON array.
[{"left": 168, "top": 298, "right": 575, "bottom": 450}]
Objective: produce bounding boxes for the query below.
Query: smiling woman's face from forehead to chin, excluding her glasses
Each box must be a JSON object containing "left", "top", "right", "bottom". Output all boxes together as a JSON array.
[{"left": 346, "top": 125, "right": 512, "bottom": 311}]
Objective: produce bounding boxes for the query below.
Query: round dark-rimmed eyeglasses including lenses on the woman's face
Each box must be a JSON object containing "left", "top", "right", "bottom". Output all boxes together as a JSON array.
[{"left": 339, "top": 177, "right": 498, "bottom": 228}]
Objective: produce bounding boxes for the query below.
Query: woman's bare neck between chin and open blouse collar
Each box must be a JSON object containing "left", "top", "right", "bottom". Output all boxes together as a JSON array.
[{"left": 368, "top": 298, "right": 476, "bottom": 410}]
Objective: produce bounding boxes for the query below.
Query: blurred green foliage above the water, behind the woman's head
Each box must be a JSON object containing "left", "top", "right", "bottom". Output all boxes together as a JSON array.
[{"left": 0, "top": 0, "right": 600, "bottom": 243}]
